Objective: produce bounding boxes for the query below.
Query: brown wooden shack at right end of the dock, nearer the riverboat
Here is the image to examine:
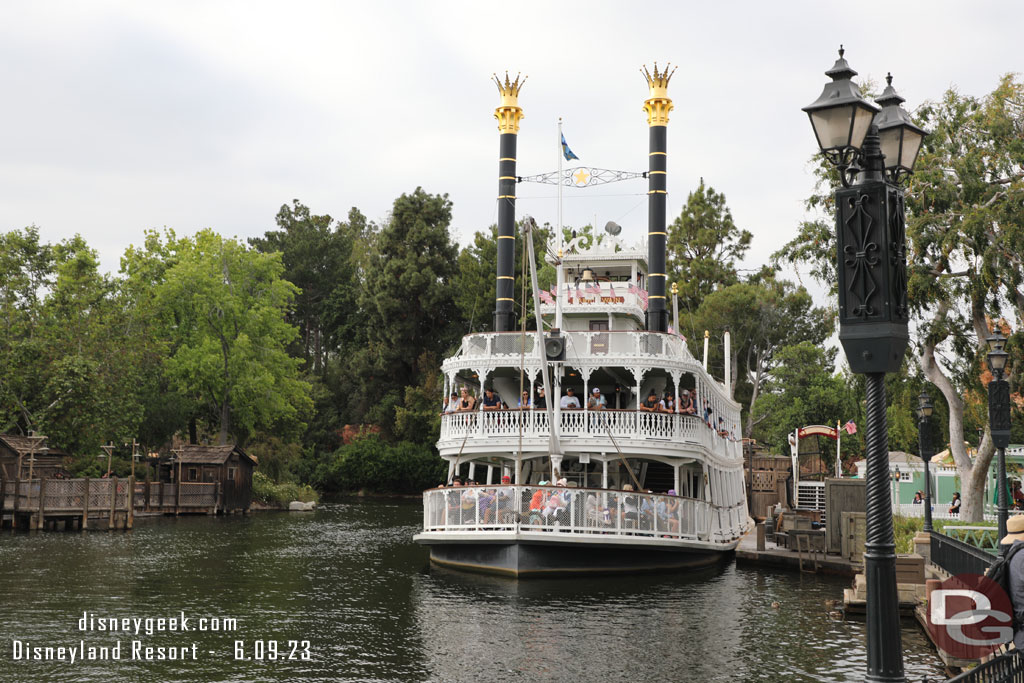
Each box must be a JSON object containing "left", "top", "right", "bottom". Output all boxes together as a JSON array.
[{"left": 170, "top": 443, "right": 256, "bottom": 512}]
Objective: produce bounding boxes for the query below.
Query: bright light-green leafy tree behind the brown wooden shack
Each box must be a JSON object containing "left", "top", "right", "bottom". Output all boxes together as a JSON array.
[{"left": 157, "top": 230, "right": 311, "bottom": 443}]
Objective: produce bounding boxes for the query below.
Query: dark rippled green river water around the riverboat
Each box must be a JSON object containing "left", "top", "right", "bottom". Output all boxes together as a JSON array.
[{"left": 0, "top": 501, "right": 940, "bottom": 683}]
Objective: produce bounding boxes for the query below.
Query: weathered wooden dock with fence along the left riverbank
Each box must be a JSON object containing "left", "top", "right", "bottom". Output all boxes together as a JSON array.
[{"left": 0, "top": 477, "right": 220, "bottom": 530}]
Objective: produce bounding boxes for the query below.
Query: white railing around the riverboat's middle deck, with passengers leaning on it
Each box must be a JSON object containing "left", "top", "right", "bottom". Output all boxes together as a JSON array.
[{"left": 440, "top": 410, "right": 739, "bottom": 454}]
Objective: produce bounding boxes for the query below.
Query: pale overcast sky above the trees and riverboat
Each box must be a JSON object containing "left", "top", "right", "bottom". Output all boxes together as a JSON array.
[{"left": 0, "top": 0, "right": 1024, "bottom": 294}]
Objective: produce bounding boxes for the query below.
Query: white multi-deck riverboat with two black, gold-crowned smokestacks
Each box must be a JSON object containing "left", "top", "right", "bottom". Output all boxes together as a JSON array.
[{"left": 415, "top": 67, "right": 750, "bottom": 578}]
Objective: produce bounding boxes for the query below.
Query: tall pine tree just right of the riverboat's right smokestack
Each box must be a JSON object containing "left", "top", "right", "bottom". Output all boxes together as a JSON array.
[{"left": 668, "top": 178, "right": 754, "bottom": 311}]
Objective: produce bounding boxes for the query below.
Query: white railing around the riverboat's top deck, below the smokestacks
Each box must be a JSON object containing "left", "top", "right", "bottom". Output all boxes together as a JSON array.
[{"left": 461, "top": 330, "right": 694, "bottom": 360}]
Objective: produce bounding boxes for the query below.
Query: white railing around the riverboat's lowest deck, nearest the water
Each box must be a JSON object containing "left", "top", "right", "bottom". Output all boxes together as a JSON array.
[{"left": 423, "top": 486, "right": 746, "bottom": 542}]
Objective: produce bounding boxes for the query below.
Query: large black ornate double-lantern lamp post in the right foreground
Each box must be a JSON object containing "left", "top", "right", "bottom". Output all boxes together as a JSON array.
[{"left": 804, "top": 47, "right": 925, "bottom": 681}]
